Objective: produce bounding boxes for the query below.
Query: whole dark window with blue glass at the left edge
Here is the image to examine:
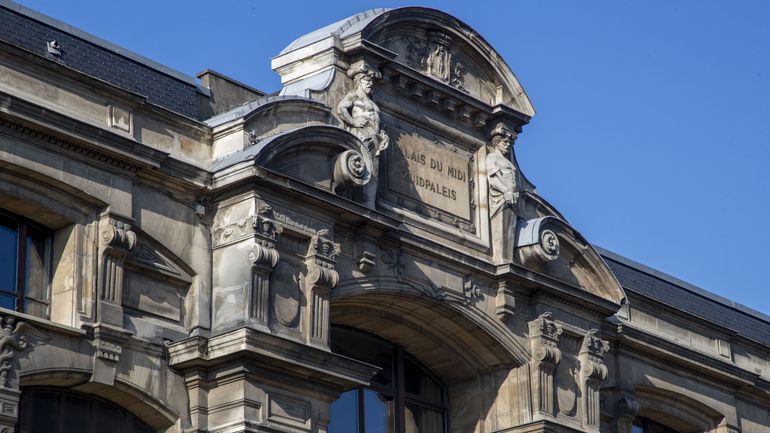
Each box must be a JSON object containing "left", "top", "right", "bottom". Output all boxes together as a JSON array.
[{"left": 0, "top": 210, "right": 51, "bottom": 317}]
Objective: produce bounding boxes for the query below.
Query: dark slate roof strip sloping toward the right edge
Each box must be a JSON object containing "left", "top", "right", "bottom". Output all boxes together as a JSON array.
[{"left": 597, "top": 247, "right": 770, "bottom": 346}]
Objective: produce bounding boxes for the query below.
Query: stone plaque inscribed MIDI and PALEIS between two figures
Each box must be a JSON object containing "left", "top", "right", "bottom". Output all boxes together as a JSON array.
[{"left": 389, "top": 135, "right": 471, "bottom": 220}]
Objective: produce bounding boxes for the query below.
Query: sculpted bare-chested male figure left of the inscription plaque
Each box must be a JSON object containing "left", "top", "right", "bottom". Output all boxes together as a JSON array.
[{"left": 337, "top": 65, "right": 390, "bottom": 159}]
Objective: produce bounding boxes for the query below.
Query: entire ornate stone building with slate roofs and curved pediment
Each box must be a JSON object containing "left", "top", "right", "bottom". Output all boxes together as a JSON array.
[{"left": 0, "top": 0, "right": 770, "bottom": 433}]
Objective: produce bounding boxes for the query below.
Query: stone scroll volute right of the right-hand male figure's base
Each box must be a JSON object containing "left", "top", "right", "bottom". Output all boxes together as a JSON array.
[{"left": 516, "top": 217, "right": 559, "bottom": 269}]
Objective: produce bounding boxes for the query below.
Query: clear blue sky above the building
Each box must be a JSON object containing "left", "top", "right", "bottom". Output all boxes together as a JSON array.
[{"left": 16, "top": 0, "right": 770, "bottom": 314}]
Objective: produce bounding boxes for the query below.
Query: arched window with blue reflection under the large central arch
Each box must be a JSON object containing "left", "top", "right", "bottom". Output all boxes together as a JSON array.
[{"left": 329, "top": 326, "right": 448, "bottom": 433}]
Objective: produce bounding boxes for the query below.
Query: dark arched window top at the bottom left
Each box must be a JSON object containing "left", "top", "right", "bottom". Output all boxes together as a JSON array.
[{"left": 16, "top": 388, "right": 155, "bottom": 433}]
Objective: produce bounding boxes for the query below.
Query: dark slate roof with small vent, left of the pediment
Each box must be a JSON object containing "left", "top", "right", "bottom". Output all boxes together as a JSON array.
[{"left": 0, "top": 0, "right": 206, "bottom": 119}]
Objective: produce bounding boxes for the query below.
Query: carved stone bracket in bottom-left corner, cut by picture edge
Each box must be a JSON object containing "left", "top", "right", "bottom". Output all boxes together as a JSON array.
[{"left": 0, "top": 315, "right": 43, "bottom": 433}]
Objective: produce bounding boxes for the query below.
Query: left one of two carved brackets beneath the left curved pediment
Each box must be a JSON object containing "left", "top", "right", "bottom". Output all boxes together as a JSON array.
[{"left": 248, "top": 204, "right": 283, "bottom": 326}]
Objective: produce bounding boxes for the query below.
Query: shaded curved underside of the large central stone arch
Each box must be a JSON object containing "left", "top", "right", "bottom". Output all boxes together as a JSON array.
[{"left": 331, "top": 278, "right": 528, "bottom": 382}]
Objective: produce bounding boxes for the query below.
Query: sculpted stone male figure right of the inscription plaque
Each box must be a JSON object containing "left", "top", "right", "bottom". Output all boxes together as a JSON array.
[{"left": 487, "top": 125, "right": 519, "bottom": 217}]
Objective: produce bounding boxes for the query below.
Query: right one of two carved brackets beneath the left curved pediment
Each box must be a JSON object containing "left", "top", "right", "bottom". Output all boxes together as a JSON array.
[{"left": 305, "top": 229, "right": 340, "bottom": 347}]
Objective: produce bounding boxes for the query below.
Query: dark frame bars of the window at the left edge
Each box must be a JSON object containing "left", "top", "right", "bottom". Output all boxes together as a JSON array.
[{"left": 0, "top": 209, "right": 53, "bottom": 319}]
